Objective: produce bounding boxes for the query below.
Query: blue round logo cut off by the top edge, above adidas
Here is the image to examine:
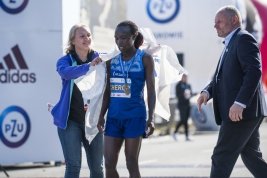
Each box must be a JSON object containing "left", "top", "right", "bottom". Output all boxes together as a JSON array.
[{"left": 0, "top": 0, "right": 29, "bottom": 14}]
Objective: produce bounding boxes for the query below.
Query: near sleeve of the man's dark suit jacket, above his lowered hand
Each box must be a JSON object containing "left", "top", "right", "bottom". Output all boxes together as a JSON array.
[{"left": 235, "top": 34, "right": 262, "bottom": 106}]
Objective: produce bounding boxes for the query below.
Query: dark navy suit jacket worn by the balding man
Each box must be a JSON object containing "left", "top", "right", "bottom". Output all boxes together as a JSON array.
[{"left": 204, "top": 29, "right": 267, "bottom": 125}]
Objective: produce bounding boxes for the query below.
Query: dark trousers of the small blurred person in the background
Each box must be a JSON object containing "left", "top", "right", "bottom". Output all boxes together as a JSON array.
[{"left": 174, "top": 105, "right": 190, "bottom": 136}]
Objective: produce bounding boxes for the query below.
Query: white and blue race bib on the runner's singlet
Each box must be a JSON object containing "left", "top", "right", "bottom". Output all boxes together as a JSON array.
[{"left": 110, "top": 78, "right": 132, "bottom": 98}]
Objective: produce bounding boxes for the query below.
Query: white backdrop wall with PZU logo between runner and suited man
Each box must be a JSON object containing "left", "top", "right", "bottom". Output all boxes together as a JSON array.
[{"left": 126, "top": 0, "right": 236, "bottom": 93}]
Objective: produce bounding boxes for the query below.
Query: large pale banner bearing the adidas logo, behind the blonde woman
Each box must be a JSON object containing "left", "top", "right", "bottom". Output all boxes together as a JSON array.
[{"left": 0, "top": 0, "right": 80, "bottom": 165}]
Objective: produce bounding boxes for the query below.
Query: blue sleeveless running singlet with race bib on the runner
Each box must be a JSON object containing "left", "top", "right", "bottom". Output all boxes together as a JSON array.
[{"left": 107, "top": 49, "right": 146, "bottom": 119}]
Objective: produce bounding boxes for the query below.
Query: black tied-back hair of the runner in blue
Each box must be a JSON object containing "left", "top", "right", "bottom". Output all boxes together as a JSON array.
[{"left": 116, "top": 20, "right": 144, "bottom": 49}]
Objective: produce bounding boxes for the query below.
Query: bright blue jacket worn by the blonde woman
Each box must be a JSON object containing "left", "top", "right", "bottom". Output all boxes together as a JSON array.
[{"left": 51, "top": 52, "right": 98, "bottom": 130}]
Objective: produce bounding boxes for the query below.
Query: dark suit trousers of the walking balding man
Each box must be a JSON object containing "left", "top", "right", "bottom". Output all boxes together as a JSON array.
[{"left": 210, "top": 117, "right": 267, "bottom": 178}]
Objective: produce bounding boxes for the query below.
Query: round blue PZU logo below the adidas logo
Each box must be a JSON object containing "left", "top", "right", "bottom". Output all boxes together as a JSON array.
[{"left": 0, "top": 106, "right": 31, "bottom": 148}]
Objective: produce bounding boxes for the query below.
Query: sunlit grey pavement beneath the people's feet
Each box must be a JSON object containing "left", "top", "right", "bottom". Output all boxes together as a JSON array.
[{"left": 0, "top": 122, "right": 267, "bottom": 178}]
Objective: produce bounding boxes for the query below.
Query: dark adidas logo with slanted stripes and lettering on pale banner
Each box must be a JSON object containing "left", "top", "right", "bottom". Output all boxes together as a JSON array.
[{"left": 0, "top": 45, "right": 36, "bottom": 83}]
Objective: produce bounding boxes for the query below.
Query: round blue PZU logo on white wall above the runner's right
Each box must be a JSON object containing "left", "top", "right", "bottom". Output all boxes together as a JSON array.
[{"left": 147, "top": 0, "right": 180, "bottom": 23}]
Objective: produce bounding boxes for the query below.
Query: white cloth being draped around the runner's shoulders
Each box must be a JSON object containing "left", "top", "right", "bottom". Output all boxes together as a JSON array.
[{"left": 74, "top": 28, "right": 186, "bottom": 143}]
